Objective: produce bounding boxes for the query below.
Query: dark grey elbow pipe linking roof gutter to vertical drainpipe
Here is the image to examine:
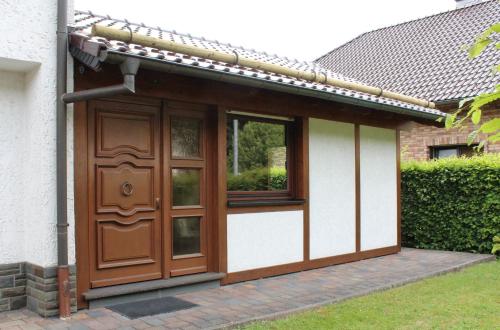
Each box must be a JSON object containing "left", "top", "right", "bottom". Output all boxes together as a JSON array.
[{"left": 62, "top": 57, "right": 140, "bottom": 104}]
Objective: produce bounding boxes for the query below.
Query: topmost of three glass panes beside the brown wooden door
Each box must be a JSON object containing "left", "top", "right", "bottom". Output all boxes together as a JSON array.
[{"left": 171, "top": 117, "right": 201, "bottom": 158}]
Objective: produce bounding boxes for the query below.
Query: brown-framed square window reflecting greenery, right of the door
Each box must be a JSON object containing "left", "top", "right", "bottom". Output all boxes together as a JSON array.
[{"left": 227, "top": 114, "right": 293, "bottom": 199}]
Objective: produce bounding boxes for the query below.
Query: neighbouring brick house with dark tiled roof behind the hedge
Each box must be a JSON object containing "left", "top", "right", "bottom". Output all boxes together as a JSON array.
[{"left": 315, "top": 0, "right": 500, "bottom": 160}]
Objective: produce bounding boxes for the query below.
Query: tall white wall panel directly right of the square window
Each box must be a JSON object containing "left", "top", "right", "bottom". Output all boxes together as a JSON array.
[{"left": 309, "top": 118, "right": 356, "bottom": 259}]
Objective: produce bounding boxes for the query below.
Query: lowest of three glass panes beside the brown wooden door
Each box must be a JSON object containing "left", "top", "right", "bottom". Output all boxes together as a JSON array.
[{"left": 173, "top": 217, "right": 201, "bottom": 256}]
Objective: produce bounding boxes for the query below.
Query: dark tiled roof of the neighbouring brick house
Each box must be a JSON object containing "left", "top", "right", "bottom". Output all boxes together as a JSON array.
[{"left": 315, "top": 0, "right": 500, "bottom": 102}]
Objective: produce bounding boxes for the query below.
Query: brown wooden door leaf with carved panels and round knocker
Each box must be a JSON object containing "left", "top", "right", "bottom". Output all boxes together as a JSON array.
[{"left": 88, "top": 101, "right": 162, "bottom": 287}]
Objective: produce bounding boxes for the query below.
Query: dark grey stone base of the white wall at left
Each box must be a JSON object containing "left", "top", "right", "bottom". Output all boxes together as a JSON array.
[{"left": 0, "top": 262, "right": 76, "bottom": 317}]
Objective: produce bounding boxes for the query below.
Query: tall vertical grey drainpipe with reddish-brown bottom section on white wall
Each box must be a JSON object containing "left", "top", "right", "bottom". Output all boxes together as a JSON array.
[{"left": 56, "top": 0, "right": 71, "bottom": 318}]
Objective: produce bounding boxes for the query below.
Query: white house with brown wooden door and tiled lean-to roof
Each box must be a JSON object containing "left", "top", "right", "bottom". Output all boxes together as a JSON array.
[{"left": 0, "top": 0, "right": 445, "bottom": 316}]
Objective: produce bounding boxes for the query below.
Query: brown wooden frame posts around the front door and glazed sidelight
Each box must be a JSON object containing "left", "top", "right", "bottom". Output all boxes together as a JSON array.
[{"left": 73, "top": 96, "right": 221, "bottom": 308}]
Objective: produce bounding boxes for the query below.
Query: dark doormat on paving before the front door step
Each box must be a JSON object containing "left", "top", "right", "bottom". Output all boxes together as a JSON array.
[{"left": 107, "top": 297, "right": 198, "bottom": 319}]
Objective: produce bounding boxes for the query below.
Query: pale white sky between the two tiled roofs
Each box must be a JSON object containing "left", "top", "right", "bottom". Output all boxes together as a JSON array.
[{"left": 74, "top": 0, "right": 455, "bottom": 61}]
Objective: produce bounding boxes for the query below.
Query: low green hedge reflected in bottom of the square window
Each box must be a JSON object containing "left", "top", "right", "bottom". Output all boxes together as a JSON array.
[{"left": 227, "top": 167, "right": 287, "bottom": 191}]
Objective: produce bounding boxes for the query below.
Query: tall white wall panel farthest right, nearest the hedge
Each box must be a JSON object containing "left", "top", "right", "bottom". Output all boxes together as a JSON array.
[{"left": 360, "top": 126, "right": 398, "bottom": 251}]
